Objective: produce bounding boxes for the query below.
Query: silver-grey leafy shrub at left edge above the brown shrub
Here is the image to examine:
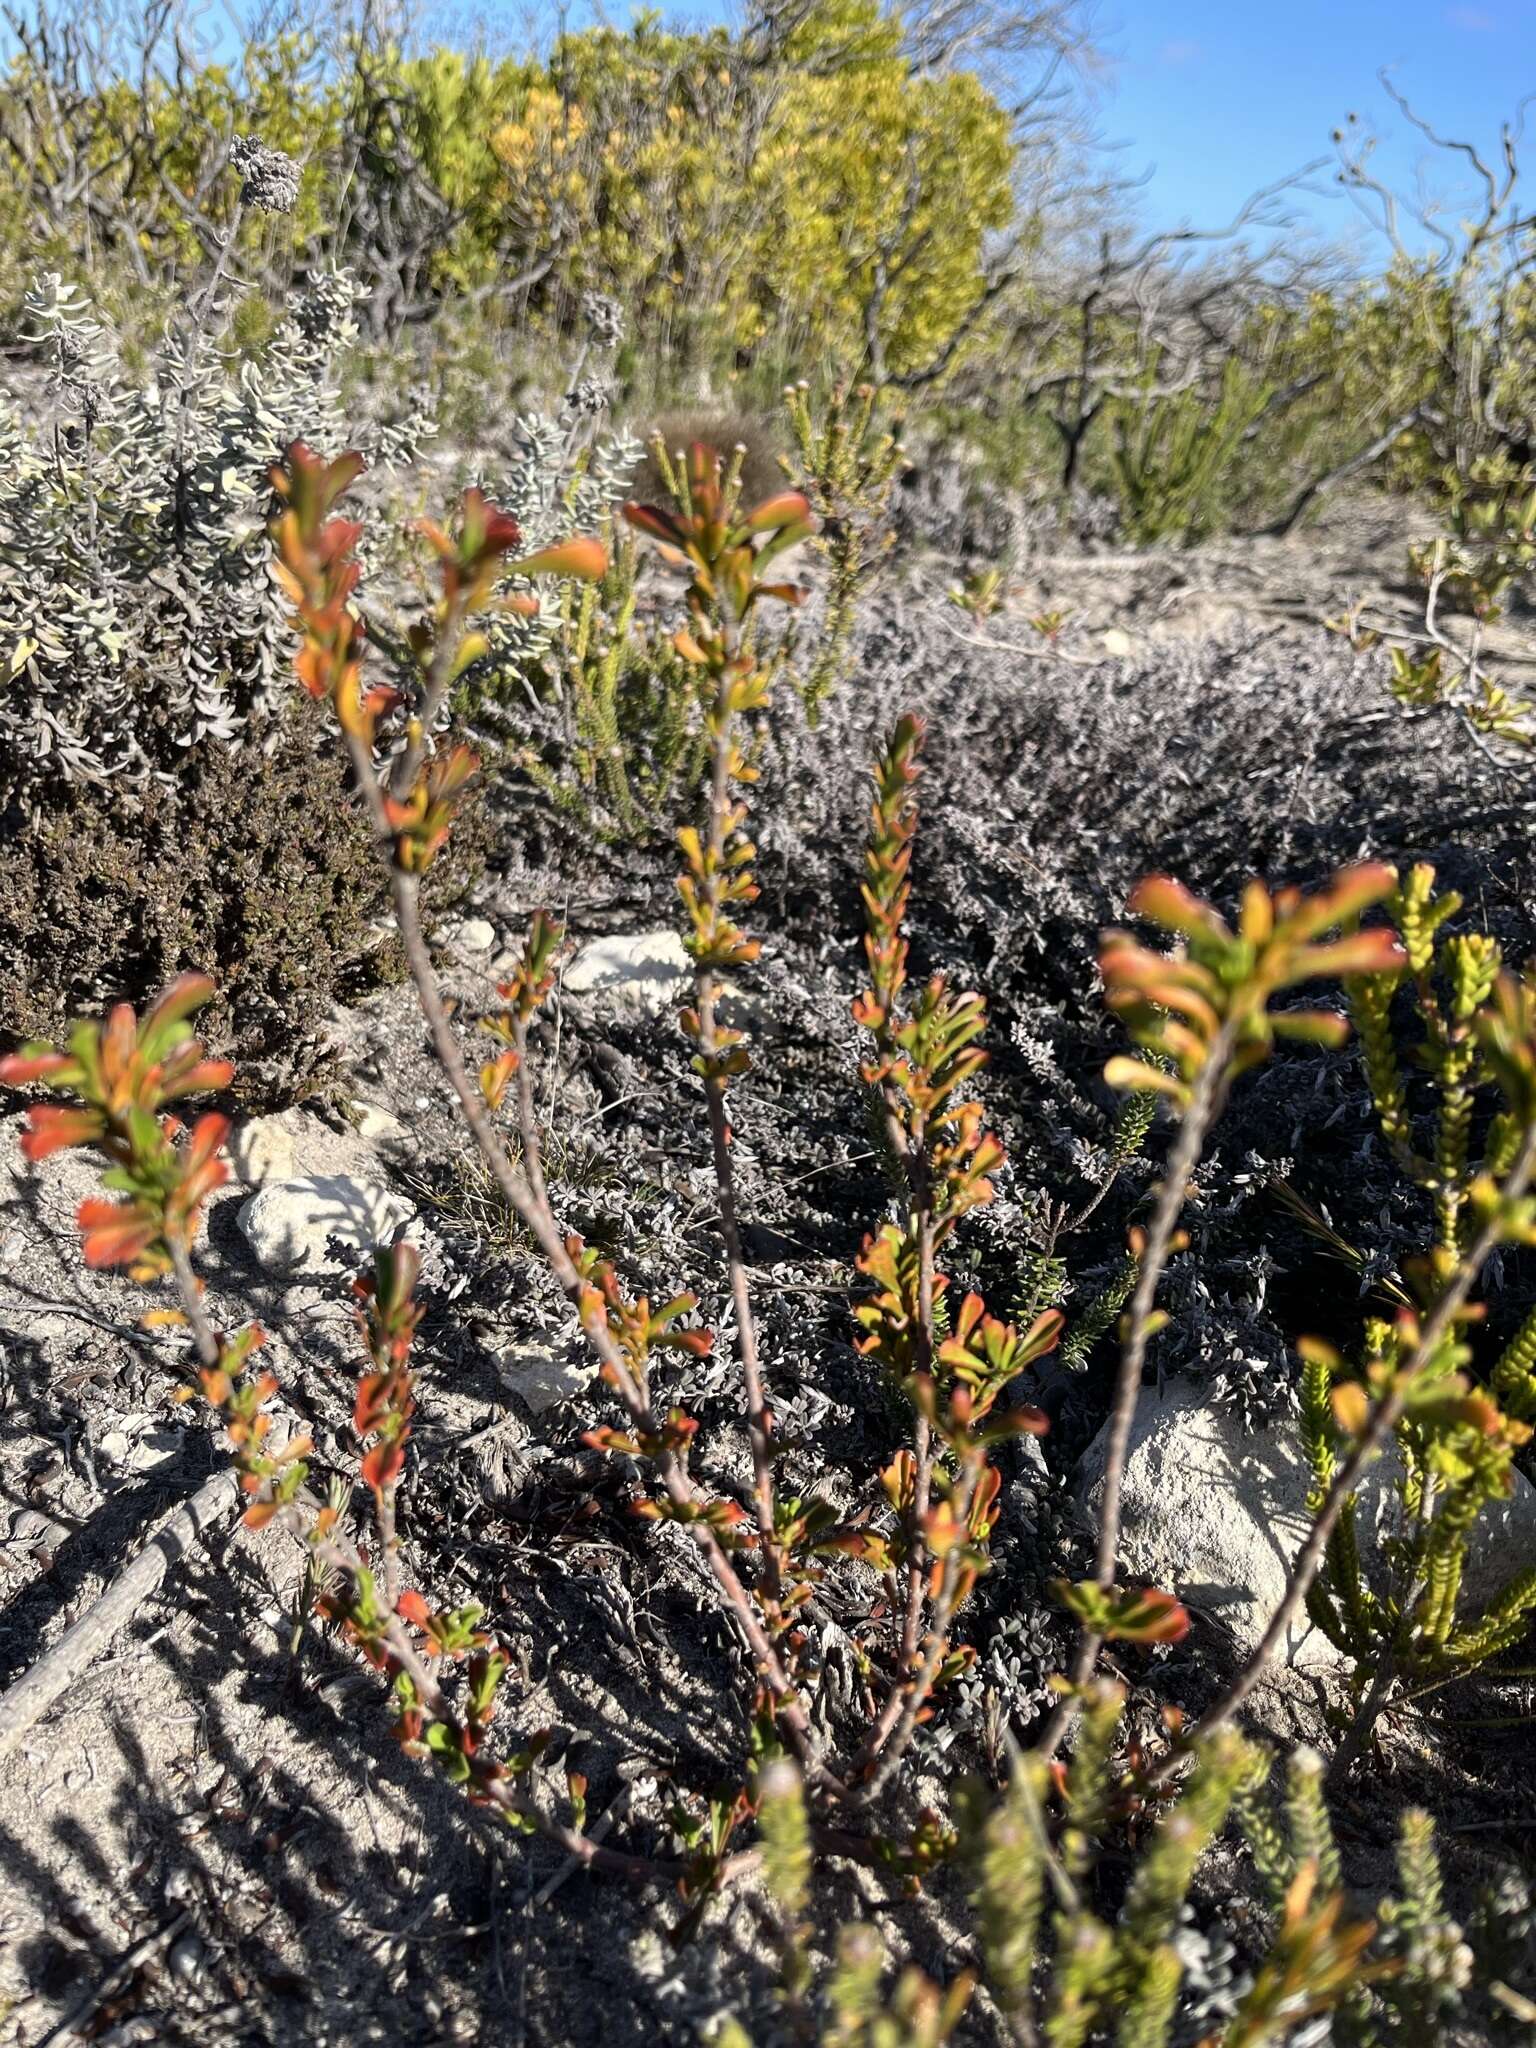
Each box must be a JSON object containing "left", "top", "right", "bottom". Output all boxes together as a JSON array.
[{"left": 0, "top": 258, "right": 434, "bottom": 793}]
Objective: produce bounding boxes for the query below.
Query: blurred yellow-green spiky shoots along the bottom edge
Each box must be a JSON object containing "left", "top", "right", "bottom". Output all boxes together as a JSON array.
[{"left": 729, "top": 1683, "right": 1409, "bottom": 2048}]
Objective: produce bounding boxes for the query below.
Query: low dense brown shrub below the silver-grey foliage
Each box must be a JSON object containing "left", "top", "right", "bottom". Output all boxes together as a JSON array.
[{"left": 0, "top": 705, "right": 462, "bottom": 1102}]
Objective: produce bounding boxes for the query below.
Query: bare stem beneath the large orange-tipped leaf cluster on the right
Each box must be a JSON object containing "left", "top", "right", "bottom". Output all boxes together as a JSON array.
[{"left": 1040, "top": 1020, "right": 1235, "bottom": 1757}]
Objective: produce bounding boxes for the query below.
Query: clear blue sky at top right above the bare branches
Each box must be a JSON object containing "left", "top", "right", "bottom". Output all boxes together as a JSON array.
[{"left": 1096, "top": 0, "right": 1536, "bottom": 236}]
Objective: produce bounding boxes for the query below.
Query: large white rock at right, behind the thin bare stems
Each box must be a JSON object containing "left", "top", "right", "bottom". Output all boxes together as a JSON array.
[{"left": 1077, "top": 1380, "right": 1536, "bottom": 1669}]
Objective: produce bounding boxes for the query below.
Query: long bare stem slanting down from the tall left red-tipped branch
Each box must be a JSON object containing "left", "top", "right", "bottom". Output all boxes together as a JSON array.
[{"left": 346, "top": 733, "right": 840, "bottom": 1790}]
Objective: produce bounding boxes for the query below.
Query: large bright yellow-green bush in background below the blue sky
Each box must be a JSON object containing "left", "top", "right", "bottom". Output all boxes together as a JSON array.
[{"left": 494, "top": 0, "right": 1012, "bottom": 373}]
